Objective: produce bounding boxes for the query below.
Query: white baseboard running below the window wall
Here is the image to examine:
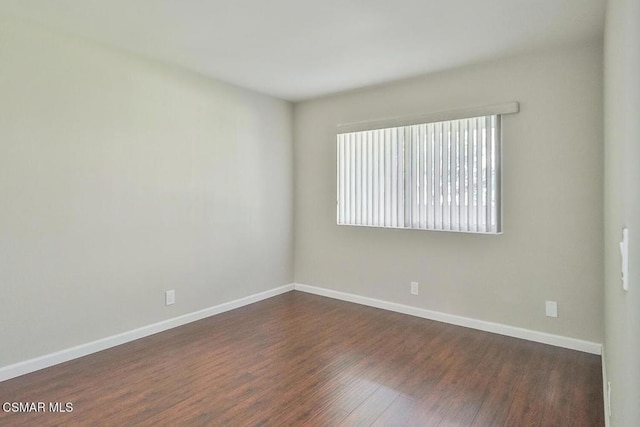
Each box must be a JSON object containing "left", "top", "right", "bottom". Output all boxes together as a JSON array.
[{"left": 294, "top": 283, "right": 602, "bottom": 354}]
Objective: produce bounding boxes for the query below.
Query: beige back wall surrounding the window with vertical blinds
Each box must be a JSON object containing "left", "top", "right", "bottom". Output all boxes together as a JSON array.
[{"left": 294, "top": 40, "right": 603, "bottom": 342}]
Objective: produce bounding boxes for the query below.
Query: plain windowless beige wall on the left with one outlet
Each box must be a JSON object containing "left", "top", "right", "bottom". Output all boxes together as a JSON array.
[{"left": 0, "top": 21, "right": 293, "bottom": 367}]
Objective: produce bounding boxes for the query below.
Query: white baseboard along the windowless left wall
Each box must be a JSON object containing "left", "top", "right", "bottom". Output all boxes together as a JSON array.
[{"left": 0, "top": 284, "right": 294, "bottom": 381}]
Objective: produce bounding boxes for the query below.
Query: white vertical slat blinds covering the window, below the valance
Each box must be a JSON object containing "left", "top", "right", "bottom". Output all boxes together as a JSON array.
[{"left": 337, "top": 115, "right": 501, "bottom": 233}]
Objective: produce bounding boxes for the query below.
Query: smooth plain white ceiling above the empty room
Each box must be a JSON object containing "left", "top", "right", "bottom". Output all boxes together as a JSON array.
[{"left": 0, "top": 0, "right": 606, "bottom": 101}]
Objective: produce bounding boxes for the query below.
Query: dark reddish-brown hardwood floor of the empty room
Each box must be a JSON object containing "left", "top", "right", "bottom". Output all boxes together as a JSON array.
[{"left": 0, "top": 292, "right": 604, "bottom": 427}]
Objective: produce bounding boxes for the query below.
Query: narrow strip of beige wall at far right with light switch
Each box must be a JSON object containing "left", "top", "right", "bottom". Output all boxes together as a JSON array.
[{"left": 604, "top": 0, "right": 640, "bottom": 427}]
